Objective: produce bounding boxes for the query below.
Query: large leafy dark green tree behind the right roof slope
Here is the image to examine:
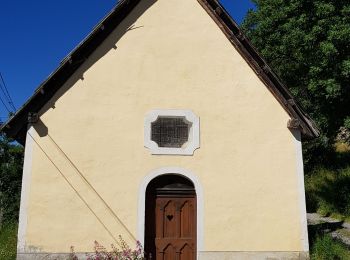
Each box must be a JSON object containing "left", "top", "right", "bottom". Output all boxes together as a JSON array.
[{"left": 242, "top": 0, "right": 350, "bottom": 167}]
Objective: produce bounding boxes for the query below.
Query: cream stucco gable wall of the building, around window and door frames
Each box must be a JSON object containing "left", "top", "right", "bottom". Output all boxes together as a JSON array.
[{"left": 22, "top": 0, "right": 305, "bottom": 252}]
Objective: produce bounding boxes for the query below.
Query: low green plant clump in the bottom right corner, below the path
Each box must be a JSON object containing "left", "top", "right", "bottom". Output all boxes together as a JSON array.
[{"left": 310, "top": 235, "right": 350, "bottom": 260}]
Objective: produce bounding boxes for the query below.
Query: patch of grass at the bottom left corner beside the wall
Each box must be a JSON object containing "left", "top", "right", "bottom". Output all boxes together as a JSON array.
[{"left": 0, "top": 223, "right": 17, "bottom": 260}]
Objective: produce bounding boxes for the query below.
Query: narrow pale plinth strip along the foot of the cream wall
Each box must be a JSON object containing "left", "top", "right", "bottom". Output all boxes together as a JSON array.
[{"left": 17, "top": 251, "right": 309, "bottom": 260}]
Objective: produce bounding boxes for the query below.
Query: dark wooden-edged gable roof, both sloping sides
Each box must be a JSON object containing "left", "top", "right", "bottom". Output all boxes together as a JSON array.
[{"left": 0, "top": 0, "right": 319, "bottom": 144}]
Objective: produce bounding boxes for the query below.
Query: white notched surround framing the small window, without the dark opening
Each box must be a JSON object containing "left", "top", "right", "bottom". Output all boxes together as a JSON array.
[{"left": 144, "top": 109, "right": 200, "bottom": 155}]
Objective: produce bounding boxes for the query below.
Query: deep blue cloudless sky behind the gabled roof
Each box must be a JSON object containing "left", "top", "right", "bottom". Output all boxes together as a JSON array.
[{"left": 0, "top": 0, "right": 253, "bottom": 121}]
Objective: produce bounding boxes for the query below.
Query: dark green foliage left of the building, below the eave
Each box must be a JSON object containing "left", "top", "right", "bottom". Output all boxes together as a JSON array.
[{"left": 0, "top": 136, "right": 23, "bottom": 222}]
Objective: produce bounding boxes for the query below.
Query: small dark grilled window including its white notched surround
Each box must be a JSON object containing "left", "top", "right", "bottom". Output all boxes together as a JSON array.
[{"left": 145, "top": 110, "right": 199, "bottom": 155}]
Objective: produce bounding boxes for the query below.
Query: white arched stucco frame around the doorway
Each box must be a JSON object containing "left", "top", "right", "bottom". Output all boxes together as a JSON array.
[{"left": 137, "top": 167, "right": 204, "bottom": 259}]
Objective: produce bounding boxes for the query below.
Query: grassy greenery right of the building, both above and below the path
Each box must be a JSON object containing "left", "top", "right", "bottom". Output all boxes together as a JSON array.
[{"left": 305, "top": 143, "right": 350, "bottom": 260}]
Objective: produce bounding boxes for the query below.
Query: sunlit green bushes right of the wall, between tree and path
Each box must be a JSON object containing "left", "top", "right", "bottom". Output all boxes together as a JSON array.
[{"left": 305, "top": 167, "right": 350, "bottom": 218}]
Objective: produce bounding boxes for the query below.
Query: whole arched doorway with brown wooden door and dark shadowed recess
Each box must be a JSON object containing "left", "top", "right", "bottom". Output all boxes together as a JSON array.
[{"left": 145, "top": 175, "right": 197, "bottom": 260}]
